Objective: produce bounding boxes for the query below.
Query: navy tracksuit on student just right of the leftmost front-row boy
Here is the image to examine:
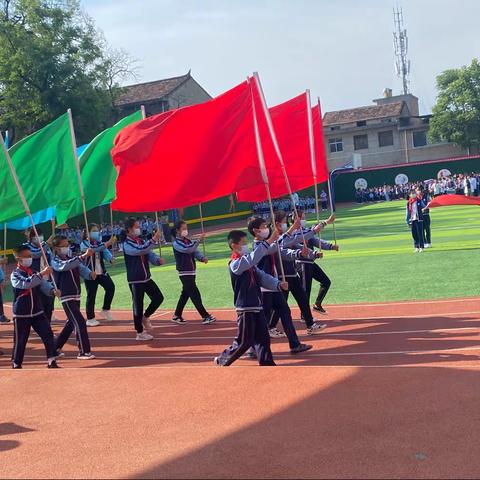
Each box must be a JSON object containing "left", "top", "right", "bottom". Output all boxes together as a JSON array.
[{"left": 52, "top": 255, "right": 92, "bottom": 355}]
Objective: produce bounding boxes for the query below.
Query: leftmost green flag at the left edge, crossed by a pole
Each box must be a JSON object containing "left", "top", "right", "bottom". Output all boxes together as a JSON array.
[{"left": 0, "top": 113, "right": 79, "bottom": 223}]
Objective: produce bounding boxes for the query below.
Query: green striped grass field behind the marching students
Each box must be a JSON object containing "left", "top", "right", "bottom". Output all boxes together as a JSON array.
[{"left": 3, "top": 201, "right": 480, "bottom": 309}]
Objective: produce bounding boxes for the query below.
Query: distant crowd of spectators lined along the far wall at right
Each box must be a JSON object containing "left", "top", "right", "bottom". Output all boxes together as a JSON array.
[{"left": 355, "top": 172, "right": 480, "bottom": 203}]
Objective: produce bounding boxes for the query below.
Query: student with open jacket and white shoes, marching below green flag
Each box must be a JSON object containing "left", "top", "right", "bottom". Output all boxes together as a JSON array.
[{"left": 80, "top": 223, "right": 115, "bottom": 327}]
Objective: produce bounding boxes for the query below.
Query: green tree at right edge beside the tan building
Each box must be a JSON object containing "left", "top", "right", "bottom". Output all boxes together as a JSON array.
[{"left": 429, "top": 59, "right": 480, "bottom": 150}]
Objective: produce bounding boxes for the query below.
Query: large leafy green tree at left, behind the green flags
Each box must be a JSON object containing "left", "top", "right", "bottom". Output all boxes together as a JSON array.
[{"left": 0, "top": 0, "right": 136, "bottom": 144}]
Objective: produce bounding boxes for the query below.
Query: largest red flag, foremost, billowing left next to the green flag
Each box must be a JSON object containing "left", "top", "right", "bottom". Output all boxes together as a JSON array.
[{"left": 112, "top": 81, "right": 268, "bottom": 212}]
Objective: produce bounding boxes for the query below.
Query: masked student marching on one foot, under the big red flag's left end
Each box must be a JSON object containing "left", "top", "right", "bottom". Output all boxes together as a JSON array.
[{"left": 123, "top": 218, "right": 165, "bottom": 341}]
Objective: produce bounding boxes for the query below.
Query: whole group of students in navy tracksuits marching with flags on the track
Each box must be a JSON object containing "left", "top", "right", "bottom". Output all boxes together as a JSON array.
[{"left": 0, "top": 210, "right": 339, "bottom": 369}]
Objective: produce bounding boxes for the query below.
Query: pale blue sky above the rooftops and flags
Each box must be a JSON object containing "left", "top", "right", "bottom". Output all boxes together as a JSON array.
[{"left": 81, "top": 0, "right": 480, "bottom": 113}]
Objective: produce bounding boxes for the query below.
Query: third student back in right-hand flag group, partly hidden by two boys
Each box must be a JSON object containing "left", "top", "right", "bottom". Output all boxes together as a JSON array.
[{"left": 269, "top": 210, "right": 328, "bottom": 335}]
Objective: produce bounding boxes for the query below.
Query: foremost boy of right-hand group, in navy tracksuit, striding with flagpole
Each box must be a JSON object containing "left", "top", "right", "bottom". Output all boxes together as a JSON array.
[{"left": 214, "top": 230, "right": 282, "bottom": 367}]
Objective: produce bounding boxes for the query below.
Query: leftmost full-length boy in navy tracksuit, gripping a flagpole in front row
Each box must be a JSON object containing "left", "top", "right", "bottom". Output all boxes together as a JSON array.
[{"left": 10, "top": 245, "right": 60, "bottom": 368}]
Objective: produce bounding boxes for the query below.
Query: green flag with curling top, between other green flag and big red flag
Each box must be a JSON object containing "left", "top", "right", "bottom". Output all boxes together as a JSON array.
[{"left": 56, "top": 111, "right": 143, "bottom": 224}]
